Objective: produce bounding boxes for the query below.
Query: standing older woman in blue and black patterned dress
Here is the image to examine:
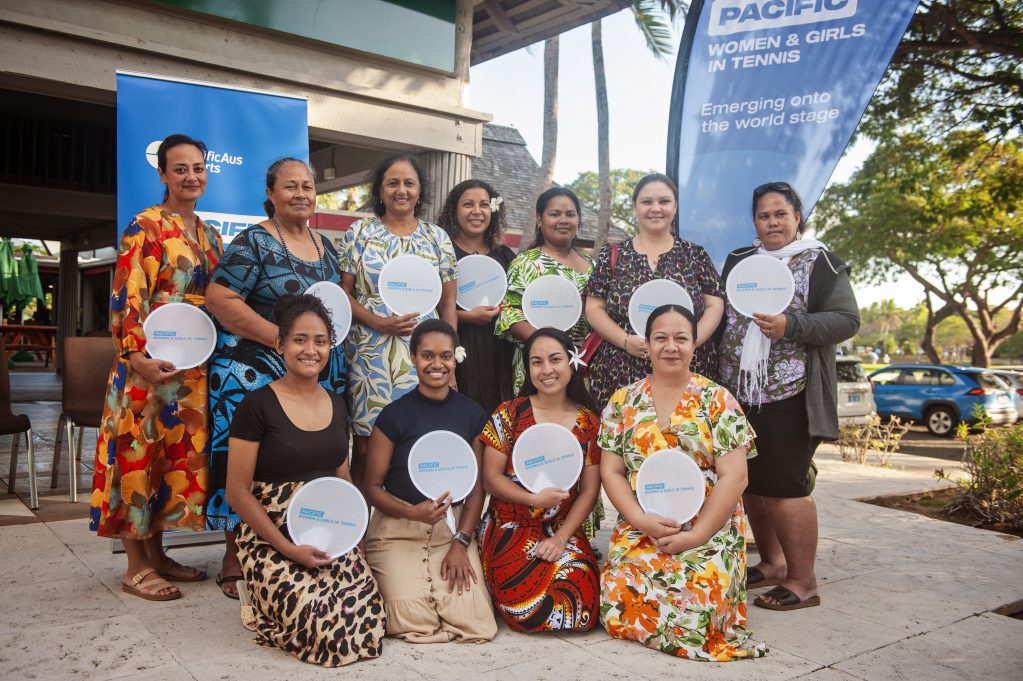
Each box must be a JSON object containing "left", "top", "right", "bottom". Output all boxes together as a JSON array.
[{"left": 207, "top": 158, "right": 346, "bottom": 598}]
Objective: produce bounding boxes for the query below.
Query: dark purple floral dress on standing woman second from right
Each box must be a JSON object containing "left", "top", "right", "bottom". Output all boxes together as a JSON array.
[{"left": 586, "top": 238, "right": 724, "bottom": 409}]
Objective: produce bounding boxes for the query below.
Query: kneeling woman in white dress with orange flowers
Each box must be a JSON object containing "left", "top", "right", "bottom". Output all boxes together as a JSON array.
[{"left": 597, "top": 305, "right": 767, "bottom": 662}]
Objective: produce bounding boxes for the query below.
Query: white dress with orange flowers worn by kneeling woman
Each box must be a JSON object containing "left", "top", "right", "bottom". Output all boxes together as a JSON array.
[{"left": 597, "top": 374, "right": 767, "bottom": 662}]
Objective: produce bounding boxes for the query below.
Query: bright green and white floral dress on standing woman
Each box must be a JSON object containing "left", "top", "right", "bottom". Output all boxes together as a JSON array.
[{"left": 494, "top": 248, "right": 593, "bottom": 395}]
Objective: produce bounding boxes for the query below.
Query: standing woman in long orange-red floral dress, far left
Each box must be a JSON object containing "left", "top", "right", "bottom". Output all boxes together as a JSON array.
[{"left": 89, "top": 135, "right": 223, "bottom": 600}]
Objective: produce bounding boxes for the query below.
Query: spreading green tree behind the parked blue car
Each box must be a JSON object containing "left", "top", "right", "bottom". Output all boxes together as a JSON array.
[{"left": 813, "top": 131, "right": 1023, "bottom": 366}]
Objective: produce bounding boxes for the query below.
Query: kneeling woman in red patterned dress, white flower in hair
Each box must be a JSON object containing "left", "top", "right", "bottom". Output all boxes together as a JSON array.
[{"left": 480, "top": 328, "right": 601, "bottom": 632}]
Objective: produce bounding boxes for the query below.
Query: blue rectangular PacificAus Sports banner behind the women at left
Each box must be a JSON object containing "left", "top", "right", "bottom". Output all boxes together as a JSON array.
[{"left": 117, "top": 73, "right": 309, "bottom": 245}]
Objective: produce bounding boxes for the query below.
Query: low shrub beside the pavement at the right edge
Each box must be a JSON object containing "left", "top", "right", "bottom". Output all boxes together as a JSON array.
[{"left": 935, "top": 424, "right": 1023, "bottom": 530}]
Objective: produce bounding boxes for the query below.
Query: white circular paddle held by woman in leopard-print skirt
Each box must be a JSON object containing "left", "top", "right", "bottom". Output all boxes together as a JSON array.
[{"left": 285, "top": 478, "right": 369, "bottom": 558}]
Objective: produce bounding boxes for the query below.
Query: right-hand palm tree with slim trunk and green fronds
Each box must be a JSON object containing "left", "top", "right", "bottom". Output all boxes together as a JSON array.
[{"left": 589, "top": 0, "right": 690, "bottom": 254}]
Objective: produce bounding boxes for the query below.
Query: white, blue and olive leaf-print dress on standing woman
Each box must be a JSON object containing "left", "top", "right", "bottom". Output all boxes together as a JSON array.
[{"left": 341, "top": 218, "right": 456, "bottom": 437}]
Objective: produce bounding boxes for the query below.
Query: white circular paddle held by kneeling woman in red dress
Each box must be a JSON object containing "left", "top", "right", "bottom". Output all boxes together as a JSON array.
[{"left": 512, "top": 423, "right": 583, "bottom": 494}]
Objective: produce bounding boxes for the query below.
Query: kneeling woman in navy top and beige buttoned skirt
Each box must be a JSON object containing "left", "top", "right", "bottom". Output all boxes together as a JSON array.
[{"left": 365, "top": 319, "right": 497, "bottom": 643}]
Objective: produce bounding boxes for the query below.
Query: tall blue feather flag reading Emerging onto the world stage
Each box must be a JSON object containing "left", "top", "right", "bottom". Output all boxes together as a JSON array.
[{"left": 667, "top": 0, "right": 918, "bottom": 267}]
